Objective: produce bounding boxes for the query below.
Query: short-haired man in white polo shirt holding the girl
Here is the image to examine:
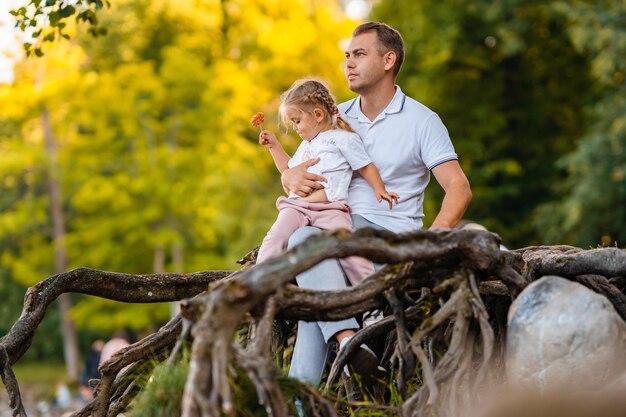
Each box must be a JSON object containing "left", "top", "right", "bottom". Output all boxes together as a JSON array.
[{"left": 281, "top": 22, "right": 472, "bottom": 385}]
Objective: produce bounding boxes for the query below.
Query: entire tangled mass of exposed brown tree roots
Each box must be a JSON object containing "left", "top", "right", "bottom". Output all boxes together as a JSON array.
[{"left": 0, "top": 229, "right": 626, "bottom": 417}]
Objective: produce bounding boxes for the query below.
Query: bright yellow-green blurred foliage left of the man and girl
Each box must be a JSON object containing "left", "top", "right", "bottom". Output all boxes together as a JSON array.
[{"left": 0, "top": 0, "right": 355, "bottom": 331}]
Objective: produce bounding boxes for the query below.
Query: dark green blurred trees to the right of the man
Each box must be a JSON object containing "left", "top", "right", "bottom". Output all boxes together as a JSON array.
[{"left": 371, "top": 0, "right": 626, "bottom": 247}]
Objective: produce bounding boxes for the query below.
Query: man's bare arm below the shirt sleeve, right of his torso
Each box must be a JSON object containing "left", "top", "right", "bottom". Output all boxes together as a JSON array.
[{"left": 430, "top": 160, "right": 472, "bottom": 229}]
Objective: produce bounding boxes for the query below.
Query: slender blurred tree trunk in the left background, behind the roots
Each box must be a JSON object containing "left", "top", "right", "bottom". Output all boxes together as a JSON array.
[{"left": 41, "top": 106, "right": 80, "bottom": 380}]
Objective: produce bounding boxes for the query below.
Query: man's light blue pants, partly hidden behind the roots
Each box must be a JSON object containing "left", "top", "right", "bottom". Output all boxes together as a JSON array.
[{"left": 289, "top": 215, "right": 381, "bottom": 386}]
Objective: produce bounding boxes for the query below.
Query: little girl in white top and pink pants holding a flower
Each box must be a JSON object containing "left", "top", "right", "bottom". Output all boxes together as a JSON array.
[{"left": 257, "top": 80, "right": 399, "bottom": 285}]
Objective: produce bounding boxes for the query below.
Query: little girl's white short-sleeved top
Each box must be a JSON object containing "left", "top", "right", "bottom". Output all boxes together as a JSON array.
[{"left": 288, "top": 129, "right": 374, "bottom": 202}]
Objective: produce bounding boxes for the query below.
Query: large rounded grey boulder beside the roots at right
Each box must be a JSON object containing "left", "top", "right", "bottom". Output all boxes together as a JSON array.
[{"left": 506, "top": 276, "right": 626, "bottom": 392}]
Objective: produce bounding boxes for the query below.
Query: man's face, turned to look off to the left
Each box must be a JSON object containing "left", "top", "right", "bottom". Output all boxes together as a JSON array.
[{"left": 345, "top": 32, "right": 385, "bottom": 94}]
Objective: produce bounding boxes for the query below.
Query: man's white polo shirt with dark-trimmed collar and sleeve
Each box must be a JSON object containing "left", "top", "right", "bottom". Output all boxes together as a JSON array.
[{"left": 338, "top": 86, "right": 458, "bottom": 233}]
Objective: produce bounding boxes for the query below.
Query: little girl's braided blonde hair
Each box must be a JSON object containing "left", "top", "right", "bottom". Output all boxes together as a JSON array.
[{"left": 278, "top": 79, "right": 354, "bottom": 132}]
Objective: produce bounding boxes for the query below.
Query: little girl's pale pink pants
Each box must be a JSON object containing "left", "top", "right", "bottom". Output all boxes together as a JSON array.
[{"left": 257, "top": 197, "right": 374, "bottom": 285}]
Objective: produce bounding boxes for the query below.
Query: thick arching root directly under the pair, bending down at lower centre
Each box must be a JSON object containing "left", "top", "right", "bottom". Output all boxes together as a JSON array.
[{"left": 183, "top": 229, "right": 499, "bottom": 417}]
